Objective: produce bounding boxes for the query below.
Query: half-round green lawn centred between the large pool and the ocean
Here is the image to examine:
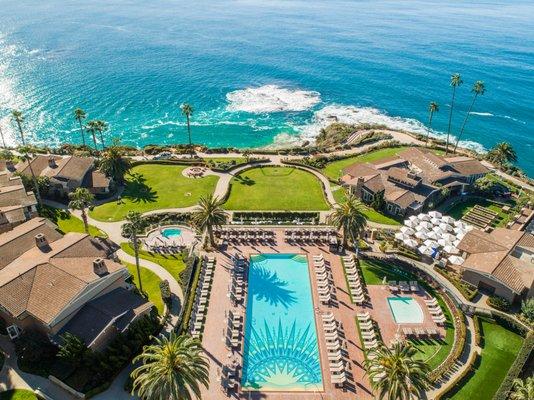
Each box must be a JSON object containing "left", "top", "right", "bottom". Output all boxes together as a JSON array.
[{"left": 225, "top": 167, "right": 330, "bottom": 211}]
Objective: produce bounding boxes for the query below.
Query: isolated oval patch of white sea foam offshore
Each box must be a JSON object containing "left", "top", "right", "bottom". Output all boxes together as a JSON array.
[{"left": 226, "top": 85, "right": 321, "bottom": 113}]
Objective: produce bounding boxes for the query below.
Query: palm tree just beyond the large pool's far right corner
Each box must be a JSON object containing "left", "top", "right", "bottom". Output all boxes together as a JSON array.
[{"left": 328, "top": 193, "right": 367, "bottom": 248}]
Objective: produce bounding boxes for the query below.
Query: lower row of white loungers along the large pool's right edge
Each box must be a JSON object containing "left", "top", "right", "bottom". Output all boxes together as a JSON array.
[{"left": 322, "top": 313, "right": 347, "bottom": 386}]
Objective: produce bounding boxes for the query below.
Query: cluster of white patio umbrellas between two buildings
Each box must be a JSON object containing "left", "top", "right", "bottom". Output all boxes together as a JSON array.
[{"left": 395, "top": 211, "right": 474, "bottom": 265}]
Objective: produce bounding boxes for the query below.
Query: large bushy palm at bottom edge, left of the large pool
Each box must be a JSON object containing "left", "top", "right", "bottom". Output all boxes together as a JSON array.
[{"left": 131, "top": 333, "right": 209, "bottom": 400}]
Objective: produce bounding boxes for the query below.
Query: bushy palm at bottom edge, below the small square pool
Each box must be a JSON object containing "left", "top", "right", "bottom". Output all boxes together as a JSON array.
[{"left": 366, "top": 341, "right": 430, "bottom": 400}]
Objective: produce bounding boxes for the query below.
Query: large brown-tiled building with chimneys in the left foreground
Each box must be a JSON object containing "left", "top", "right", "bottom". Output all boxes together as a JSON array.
[{"left": 0, "top": 218, "right": 152, "bottom": 350}]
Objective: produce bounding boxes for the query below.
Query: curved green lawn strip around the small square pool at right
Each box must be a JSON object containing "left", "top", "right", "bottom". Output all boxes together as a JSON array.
[{"left": 360, "top": 260, "right": 454, "bottom": 368}]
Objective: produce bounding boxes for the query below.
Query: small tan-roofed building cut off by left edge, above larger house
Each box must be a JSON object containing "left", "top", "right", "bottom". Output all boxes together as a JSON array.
[{"left": 0, "top": 171, "right": 37, "bottom": 233}]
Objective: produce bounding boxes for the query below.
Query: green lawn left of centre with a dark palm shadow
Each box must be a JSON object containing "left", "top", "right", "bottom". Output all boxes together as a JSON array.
[{"left": 90, "top": 164, "right": 218, "bottom": 221}]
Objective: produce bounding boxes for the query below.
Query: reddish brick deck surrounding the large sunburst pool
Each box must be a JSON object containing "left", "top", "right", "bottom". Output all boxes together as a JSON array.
[{"left": 202, "top": 229, "right": 373, "bottom": 400}]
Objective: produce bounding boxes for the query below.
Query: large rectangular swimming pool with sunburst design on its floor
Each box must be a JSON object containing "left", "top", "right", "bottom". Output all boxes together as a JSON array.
[{"left": 241, "top": 254, "right": 323, "bottom": 391}]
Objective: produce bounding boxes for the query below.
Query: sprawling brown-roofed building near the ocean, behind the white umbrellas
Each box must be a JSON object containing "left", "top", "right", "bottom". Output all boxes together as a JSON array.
[{"left": 341, "top": 147, "right": 488, "bottom": 215}]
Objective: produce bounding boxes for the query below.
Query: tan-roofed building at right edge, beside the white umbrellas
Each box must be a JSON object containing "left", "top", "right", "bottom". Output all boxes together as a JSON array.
[{"left": 458, "top": 228, "right": 534, "bottom": 303}]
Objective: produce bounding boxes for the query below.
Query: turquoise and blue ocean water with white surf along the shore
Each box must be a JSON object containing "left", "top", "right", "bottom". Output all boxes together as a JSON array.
[{"left": 0, "top": 0, "right": 534, "bottom": 176}]
